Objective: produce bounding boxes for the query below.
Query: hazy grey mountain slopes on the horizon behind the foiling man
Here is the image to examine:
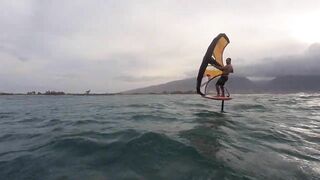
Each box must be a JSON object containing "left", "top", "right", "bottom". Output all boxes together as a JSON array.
[{"left": 122, "top": 75, "right": 320, "bottom": 94}]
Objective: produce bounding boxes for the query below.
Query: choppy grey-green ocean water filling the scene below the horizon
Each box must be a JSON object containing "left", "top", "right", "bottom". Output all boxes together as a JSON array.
[{"left": 0, "top": 93, "right": 320, "bottom": 180}]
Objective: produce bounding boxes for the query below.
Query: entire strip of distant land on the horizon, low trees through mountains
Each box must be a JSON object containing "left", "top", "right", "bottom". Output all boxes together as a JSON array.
[{"left": 0, "top": 75, "right": 320, "bottom": 96}]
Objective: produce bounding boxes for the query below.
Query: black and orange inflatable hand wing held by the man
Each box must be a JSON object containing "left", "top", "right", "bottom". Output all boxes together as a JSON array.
[{"left": 197, "top": 33, "right": 230, "bottom": 96}]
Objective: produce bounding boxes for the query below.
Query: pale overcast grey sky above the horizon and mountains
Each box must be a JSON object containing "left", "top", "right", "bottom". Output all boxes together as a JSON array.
[{"left": 0, "top": 0, "right": 320, "bottom": 93}]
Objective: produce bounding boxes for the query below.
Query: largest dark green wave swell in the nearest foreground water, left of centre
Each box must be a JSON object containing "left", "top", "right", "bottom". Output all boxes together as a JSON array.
[{"left": 0, "top": 130, "right": 240, "bottom": 179}]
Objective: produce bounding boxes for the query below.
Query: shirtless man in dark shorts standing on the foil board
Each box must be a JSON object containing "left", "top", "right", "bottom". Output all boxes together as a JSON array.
[{"left": 214, "top": 58, "right": 233, "bottom": 97}]
